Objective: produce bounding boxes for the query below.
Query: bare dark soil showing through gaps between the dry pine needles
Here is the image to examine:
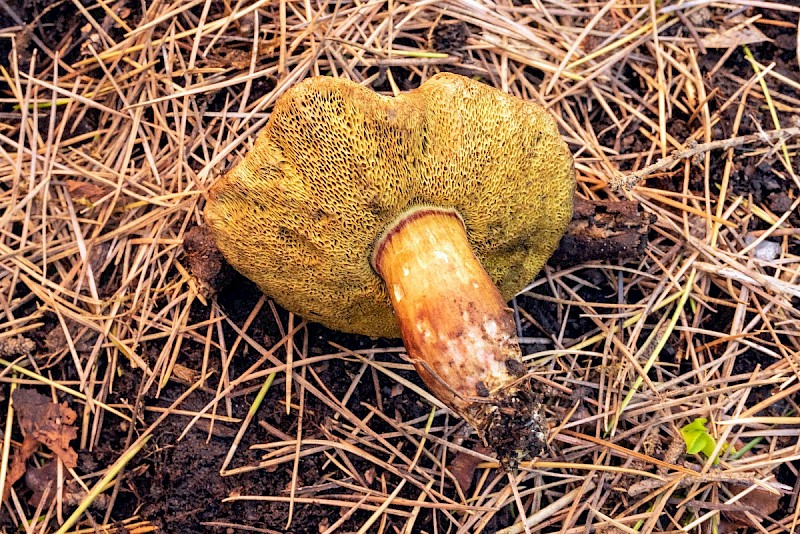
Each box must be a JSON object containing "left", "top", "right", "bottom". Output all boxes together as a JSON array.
[{"left": 0, "top": 0, "right": 800, "bottom": 533}]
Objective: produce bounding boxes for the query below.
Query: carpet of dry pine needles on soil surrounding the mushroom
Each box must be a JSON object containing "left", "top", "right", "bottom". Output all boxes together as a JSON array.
[{"left": 0, "top": 0, "right": 800, "bottom": 534}]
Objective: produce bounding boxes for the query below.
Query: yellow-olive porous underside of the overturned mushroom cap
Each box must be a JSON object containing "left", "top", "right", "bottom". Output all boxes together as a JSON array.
[{"left": 205, "top": 73, "right": 575, "bottom": 337}]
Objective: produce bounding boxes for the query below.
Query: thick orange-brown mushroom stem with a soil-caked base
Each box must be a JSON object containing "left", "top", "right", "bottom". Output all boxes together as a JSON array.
[{"left": 372, "top": 207, "right": 547, "bottom": 470}]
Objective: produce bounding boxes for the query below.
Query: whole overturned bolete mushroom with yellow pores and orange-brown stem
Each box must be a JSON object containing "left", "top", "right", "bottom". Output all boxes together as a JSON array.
[{"left": 205, "top": 73, "right": 575, "bottom": 469}]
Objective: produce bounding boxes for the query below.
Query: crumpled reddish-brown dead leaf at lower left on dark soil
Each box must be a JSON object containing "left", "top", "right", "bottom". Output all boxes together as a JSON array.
[{"left": 11, "top": 389, "right": 78, "bottom": 468}]
